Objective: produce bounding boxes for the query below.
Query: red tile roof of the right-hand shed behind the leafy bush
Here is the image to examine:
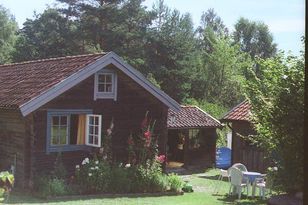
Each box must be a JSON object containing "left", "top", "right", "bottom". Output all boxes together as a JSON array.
[{"left": 220, "top": 100, "right": 251, "bottom": 121}]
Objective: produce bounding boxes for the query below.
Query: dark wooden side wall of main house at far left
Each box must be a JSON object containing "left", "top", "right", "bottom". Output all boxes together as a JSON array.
[{"left": 0, "top": 109, "right": 27, "bottom": 186}]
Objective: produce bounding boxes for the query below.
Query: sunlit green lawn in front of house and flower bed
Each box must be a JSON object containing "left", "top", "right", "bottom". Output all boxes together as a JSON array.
[{"left": 8, "top": 169, "right": 266, "bottom": 205}]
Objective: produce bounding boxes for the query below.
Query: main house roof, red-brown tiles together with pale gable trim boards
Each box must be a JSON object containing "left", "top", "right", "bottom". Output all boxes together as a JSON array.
[{"left": 0, "top": 52, "right": 180, "bottom": 116}]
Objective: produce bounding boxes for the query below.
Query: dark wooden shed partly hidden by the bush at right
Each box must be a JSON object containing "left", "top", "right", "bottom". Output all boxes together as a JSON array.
[{"left": 220, "top": 100, "right": 268, "bottom": 173}]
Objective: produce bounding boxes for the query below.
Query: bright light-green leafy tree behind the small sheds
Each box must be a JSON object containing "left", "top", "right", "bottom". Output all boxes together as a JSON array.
[{"left": 191, "top": 38, "right": 252, "bottom": 108}]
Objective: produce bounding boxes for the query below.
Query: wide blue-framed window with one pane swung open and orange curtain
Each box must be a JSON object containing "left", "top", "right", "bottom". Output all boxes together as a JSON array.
[{"left": 46, "top": 110, "right": 102, "bottom": 153}]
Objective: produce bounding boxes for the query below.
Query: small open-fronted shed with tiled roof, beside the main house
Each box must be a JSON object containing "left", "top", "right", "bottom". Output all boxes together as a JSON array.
[{"left": 167, "top": 106, "right": 222, "bottom": 167}]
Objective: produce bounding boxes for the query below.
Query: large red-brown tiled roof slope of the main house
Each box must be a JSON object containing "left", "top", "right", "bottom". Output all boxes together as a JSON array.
[{"left": 0, "top": 53, "right": 105, "bottom": 108}]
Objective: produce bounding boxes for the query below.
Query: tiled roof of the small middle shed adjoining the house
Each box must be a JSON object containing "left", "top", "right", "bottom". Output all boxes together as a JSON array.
[{"left": 167, "top": 106, "right": 222, "bottom": 129}]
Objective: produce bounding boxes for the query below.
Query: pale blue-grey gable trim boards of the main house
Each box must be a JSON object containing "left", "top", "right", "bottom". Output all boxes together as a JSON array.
[{"left": 19, "top": 52, "right": 180, "bottom": 116}]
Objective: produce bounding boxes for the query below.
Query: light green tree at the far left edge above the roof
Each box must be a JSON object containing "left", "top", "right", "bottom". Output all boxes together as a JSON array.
[{"left": 0, "top": 5, "right": 18, "bottom": 64}]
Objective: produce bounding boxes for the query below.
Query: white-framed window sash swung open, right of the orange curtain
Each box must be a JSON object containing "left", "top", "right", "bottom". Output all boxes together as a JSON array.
[{"left": 86, "top": 115, "right": 102, "bottom": 147}]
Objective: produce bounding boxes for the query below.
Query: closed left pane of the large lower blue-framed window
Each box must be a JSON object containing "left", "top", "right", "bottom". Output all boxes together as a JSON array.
[{"left": 51, "top": 115, "right": 69, "bottom": 146}]
